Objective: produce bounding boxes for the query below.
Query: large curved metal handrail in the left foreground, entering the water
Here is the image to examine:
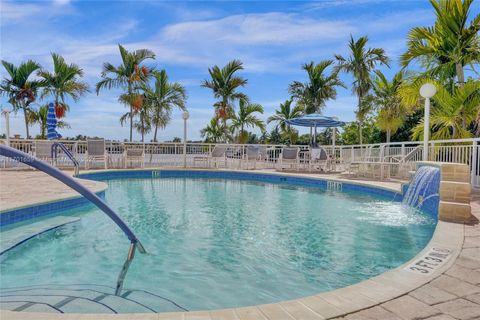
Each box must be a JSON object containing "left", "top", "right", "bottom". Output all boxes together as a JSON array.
[{"left": 0, "top": 144, "right": 147, "bottom": 295}]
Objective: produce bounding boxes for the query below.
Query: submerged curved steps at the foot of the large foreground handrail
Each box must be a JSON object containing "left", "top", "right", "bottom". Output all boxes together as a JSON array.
[{"left": 0, "top": 285, "right": 186, "bottom": 313}]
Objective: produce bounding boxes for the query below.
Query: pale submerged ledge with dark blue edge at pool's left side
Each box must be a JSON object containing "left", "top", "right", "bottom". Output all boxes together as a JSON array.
[{"left": 0, "top": 216, "right": 80, "bottom": 255}]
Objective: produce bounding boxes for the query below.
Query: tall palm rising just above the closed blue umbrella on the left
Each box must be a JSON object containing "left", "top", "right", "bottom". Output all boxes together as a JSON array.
[{"left": 38, "top": 53, "right": 88, "bottom": 118}]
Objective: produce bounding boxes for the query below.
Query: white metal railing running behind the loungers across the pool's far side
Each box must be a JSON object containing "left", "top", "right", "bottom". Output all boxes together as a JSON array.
[{"left": 0, "top": 138, "right": 480, "bottom": 187}]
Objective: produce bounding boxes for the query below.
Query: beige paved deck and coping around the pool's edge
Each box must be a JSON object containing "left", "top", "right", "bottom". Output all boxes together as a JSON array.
[{"left": 0, "top": 168, "right": 480, "bottom": 320}]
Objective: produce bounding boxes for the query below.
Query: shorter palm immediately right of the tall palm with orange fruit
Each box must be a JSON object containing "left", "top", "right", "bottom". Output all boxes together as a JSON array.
[{"left": 141, "top": 70, "right": 187, "bottom": 142}]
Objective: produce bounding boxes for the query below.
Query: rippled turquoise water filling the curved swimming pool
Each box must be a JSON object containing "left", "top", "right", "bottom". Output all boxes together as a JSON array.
[{"left": 0, "top": 178, "right": 436, "bottom": 312}]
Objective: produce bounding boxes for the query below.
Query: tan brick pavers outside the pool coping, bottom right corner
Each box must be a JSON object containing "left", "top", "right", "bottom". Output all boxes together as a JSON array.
[{"left": 337, "top": 192, "right": 480, "bottom": 320}]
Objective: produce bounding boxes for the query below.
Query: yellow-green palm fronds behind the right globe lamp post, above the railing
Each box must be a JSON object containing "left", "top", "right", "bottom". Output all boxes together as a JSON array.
[{"left": 412, "top": 80, "right": 480, "bottom": 140}]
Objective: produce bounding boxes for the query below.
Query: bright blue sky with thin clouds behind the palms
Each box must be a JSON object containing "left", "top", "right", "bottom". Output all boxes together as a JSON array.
[{"left": 0, "top": 0, "right": 468, "bottom": 140}]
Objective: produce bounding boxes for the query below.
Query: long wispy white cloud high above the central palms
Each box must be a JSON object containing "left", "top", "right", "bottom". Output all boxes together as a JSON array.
[{"left": 161, "top": 12, "right": 356, "bottom": 47}]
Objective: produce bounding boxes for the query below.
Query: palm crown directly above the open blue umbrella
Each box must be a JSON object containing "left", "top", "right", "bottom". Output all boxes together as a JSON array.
[{"left": 289, "top": 60, "right": 346, "bottom": 114}]
